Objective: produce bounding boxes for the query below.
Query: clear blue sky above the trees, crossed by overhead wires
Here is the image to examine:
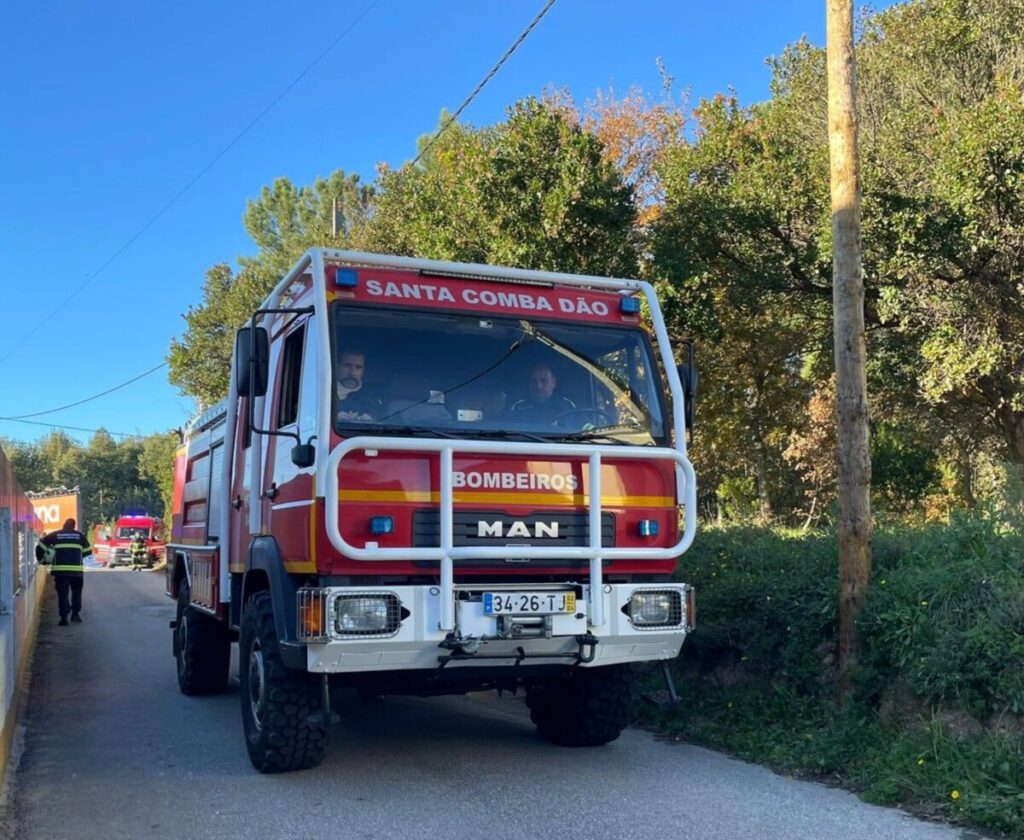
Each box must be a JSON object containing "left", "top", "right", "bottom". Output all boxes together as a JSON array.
[{"left": 0, "top": 0, "right": 888, "bottom": 440}]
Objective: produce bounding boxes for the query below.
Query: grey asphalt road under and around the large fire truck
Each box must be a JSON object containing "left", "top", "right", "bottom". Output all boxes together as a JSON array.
[{"left": 6, "top": 571, "right": 965, "bottom": 840}]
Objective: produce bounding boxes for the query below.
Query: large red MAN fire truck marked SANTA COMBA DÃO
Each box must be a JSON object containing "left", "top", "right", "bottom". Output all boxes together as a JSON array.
[{"left": 167, "top": 249, "right": 696, "bottom": 772}]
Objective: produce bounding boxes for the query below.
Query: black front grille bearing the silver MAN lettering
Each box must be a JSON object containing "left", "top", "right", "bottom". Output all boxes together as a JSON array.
[{"left": 413, "top": 509, "right": 615, "bottom": 548}]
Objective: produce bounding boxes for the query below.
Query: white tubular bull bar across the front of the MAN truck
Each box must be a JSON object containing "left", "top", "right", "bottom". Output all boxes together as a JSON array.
[{"left": 325, "top": 435, "right": 696, "bottom": 631}]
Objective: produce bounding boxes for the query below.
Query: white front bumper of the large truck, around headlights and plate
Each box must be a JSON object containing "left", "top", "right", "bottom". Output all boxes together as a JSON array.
[{"left": 299, "top": 584, "right": 693, "bottom": 674}]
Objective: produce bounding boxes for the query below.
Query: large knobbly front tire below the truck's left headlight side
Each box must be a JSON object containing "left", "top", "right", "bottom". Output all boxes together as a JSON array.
[{"left": 239, "top": 592, "right": 328, "bottom": 773}]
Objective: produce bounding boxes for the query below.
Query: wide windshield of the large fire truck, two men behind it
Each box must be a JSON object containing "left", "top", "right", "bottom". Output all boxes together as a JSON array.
[{"left": 332, "top": 304, "right": 666, "bottom": 445}]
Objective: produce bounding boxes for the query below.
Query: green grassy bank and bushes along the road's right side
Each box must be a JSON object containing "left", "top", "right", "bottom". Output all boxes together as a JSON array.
[{"left": 640, "top": 513, "right": 1024, "bottom": 836}]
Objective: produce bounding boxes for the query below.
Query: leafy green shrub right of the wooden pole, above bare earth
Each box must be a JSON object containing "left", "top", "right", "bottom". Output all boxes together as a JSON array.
[{"left": 860, "top": 516, "right": 1024, "bottom": 720}]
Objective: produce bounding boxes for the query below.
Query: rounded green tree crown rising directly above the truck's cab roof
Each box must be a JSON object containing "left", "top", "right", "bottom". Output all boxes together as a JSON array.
[{"left": 353, "top": 98, "right": 638, "bottom": 277}]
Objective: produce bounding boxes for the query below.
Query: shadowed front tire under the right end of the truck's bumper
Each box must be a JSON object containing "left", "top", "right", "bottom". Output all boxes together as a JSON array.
[{"left": 526, "top": 665, "right": 637, "bottom": 747}]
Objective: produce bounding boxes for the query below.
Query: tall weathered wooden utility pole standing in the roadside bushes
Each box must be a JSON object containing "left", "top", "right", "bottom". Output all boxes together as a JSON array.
[{"left": 825, "top": 0, "right": 871, "bottom": 703}]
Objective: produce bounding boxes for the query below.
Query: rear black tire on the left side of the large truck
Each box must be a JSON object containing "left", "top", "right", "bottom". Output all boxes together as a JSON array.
[{"left": 173, "top": 582, "right": 231, "bottom": 697}]
